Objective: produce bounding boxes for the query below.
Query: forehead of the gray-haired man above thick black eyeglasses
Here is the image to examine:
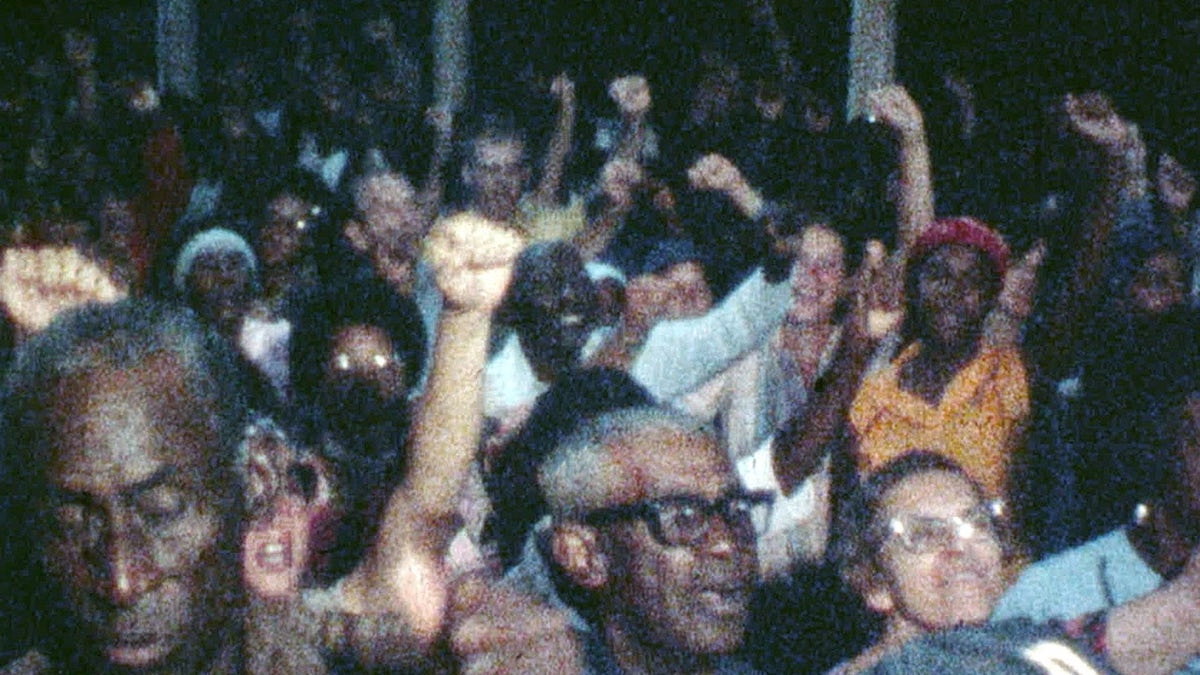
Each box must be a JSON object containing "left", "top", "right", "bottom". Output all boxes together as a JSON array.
[{"left": 607, "top": 426, "right": 734, "bottom": 501}]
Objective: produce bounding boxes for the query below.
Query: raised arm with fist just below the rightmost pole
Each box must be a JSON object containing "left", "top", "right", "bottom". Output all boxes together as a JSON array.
[{"left": 866, "top": 84, "right": 934, "bottom": 256}]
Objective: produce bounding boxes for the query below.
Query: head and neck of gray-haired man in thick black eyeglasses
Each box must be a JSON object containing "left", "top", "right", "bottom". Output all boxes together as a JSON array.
[{"left": 539, "top": 408, "right": 769, "bottom": 675}]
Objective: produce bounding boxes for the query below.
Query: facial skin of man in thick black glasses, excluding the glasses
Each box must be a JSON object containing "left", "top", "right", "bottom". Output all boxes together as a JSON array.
[{"left": 605, "top": 429, "right": 757, "bottom": 655}]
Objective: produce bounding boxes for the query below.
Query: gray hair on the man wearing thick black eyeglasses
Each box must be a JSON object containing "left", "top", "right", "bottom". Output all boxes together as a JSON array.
[{"left": 538, "top": 406, "right": 713, "bottom": 518}]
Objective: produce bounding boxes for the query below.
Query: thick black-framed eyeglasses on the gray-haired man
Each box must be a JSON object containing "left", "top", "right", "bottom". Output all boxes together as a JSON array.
[{"left": 578, "top": 491, "right": 774, "bottom": 546}]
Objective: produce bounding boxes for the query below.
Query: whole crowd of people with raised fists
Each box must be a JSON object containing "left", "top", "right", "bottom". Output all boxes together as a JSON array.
[{"left": 0, "top": 8, "right": 1200, "bottom": 675}]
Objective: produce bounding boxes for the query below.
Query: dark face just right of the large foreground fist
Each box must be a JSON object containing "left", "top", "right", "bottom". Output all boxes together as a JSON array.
[{"left": 514, "top": 242, "right": 599, "bottom": 374}]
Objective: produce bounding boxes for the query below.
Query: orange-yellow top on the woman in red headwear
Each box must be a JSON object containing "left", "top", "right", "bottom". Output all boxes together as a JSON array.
[{"left": 850, "top": 344, "right": 1030, "bottom": 497}]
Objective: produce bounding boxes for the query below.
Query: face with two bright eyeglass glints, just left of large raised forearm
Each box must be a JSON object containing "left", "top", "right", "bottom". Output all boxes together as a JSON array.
[{"left": 323, "top": 324, "right": 408, "bottom": 425}]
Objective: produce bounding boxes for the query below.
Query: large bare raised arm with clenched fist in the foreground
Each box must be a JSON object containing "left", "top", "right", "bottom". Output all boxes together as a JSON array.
[{"left": 341, "top": 214, "right": 521, "bottom": 641}]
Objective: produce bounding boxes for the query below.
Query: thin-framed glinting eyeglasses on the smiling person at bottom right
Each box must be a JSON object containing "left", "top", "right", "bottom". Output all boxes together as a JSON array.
[{"left": 881, "top": 500, "right": 1006, "bottom": 555}]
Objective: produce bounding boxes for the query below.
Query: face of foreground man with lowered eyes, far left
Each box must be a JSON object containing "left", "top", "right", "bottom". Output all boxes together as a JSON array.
[{"left": 43, "top": 356, "right": 239, "bottom": 673}]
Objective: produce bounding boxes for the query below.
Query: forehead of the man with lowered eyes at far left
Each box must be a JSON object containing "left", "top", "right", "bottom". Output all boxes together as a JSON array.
[{"left": 43, "top": 354, "right": 221, "bottom": 495}]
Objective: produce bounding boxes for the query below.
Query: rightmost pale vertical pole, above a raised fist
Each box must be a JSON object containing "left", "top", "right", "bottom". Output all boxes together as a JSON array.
[{"left": 846, "top": 0, "right": 899, "bottom": 121}]
